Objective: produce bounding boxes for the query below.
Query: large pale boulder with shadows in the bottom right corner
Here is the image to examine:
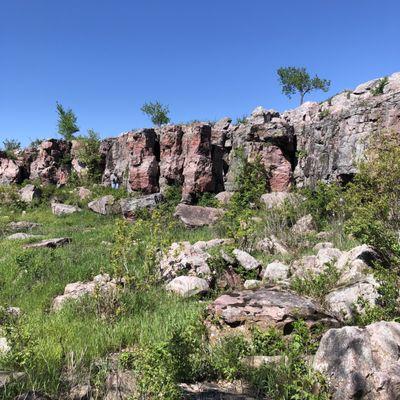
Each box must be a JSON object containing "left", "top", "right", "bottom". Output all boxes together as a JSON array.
[{"left": 314, "top": 321, "right": 400, "bottom": 400}]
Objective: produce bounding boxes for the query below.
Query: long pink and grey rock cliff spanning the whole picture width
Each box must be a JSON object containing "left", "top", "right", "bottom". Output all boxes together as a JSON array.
[{"left": 0, "top": 73, "right": 400, "bottom": 200}]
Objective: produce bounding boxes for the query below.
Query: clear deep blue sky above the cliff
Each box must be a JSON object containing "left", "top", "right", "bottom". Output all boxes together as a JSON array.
[{"left": 0, "top": 0, "right": 400, "bottom": 144}]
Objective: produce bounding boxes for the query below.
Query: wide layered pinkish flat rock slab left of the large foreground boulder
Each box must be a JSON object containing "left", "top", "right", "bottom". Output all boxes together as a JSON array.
[{"left": 209, "top": 288, "right": 338, "bottom": 333}]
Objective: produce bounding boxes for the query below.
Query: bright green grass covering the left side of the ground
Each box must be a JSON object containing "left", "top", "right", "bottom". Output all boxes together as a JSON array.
[{"left": 0, "top": 206, "right": 213, "bottom": 398}]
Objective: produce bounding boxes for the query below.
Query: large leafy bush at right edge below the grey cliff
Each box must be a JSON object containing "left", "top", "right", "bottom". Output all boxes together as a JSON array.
[{"left": 343, "top": 131, "right": 400, "bottom": 263}]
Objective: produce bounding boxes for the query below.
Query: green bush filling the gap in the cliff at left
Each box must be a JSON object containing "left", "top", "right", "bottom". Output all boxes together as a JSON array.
[{"left": 76, "top": 129, "right": 102, "bottom": 183}]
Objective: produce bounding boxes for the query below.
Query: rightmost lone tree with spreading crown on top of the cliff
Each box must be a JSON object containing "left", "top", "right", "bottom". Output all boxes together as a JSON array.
[{"left": 277, "top": 67, "right": 331, "bottom": 105}]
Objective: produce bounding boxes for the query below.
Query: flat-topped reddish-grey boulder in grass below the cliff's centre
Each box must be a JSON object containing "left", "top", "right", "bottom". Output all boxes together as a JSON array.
[{"left": 174, "top": 204, "right": 224, "bottom": 228}]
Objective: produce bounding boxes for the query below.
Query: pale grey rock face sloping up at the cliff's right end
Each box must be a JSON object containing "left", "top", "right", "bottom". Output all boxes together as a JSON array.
[{"left": 283, "top": 73, "right": 400, "bottom": 186}]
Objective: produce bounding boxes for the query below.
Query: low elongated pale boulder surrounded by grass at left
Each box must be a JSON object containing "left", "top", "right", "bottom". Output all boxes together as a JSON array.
[{"left": 52, "top": 274, "right": 117, "bottom": 311}]
